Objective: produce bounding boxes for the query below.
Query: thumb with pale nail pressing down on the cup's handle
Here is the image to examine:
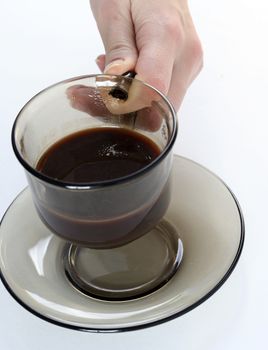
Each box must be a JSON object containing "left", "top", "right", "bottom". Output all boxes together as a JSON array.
[{"left": 91, "top": 0, "right": 137, "bottom": 74}]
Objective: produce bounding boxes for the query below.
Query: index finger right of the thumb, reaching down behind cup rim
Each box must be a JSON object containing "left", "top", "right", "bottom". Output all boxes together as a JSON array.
[{"left": 129, "top": 0, "right": 184, "bottom": 94}]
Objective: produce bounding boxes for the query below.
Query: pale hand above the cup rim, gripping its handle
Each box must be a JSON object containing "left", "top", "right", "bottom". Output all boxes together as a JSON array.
[{"left": 68, "top": 0, "right": 203, "bottom": 130}]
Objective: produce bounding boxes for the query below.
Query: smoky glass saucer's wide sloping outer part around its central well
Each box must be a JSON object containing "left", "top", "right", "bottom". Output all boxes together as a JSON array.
[{"left": 0, "top": 156, "right": 245, "bottom": 332}]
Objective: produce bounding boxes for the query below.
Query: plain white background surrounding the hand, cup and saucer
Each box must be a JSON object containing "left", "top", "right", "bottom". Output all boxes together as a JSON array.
[{"left": 0, "top": 0, "right": 268, "bottom": 350}]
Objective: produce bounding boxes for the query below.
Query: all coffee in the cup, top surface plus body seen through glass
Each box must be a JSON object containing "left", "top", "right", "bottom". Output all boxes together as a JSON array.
[{"left": 33, "top": 127, "right": 170, "bottom": 248}]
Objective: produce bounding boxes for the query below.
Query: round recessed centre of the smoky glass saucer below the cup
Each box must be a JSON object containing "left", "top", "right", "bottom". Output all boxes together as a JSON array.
[{"left": 63, "top": 220, "right": 183, "bottom": 301}]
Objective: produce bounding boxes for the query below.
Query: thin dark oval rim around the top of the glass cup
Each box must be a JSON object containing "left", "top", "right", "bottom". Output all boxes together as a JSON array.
[{"left": 11, "top": 74, "right": 178, "bottom": 190}]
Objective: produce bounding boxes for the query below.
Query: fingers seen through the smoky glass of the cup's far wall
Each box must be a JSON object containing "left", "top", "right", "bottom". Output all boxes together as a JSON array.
[{"left": 66, "top": 76, "right": 165, "bottom": 132}]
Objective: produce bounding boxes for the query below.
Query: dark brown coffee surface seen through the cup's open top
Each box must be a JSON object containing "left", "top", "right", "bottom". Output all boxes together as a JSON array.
[{"left": 36, "top": 128, "right": 160, "bottom": 184}]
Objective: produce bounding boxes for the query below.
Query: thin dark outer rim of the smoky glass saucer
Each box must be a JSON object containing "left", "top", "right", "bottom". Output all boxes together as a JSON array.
[{"left": 0, "top": 154, "right": 245, "bottom": 333}]
